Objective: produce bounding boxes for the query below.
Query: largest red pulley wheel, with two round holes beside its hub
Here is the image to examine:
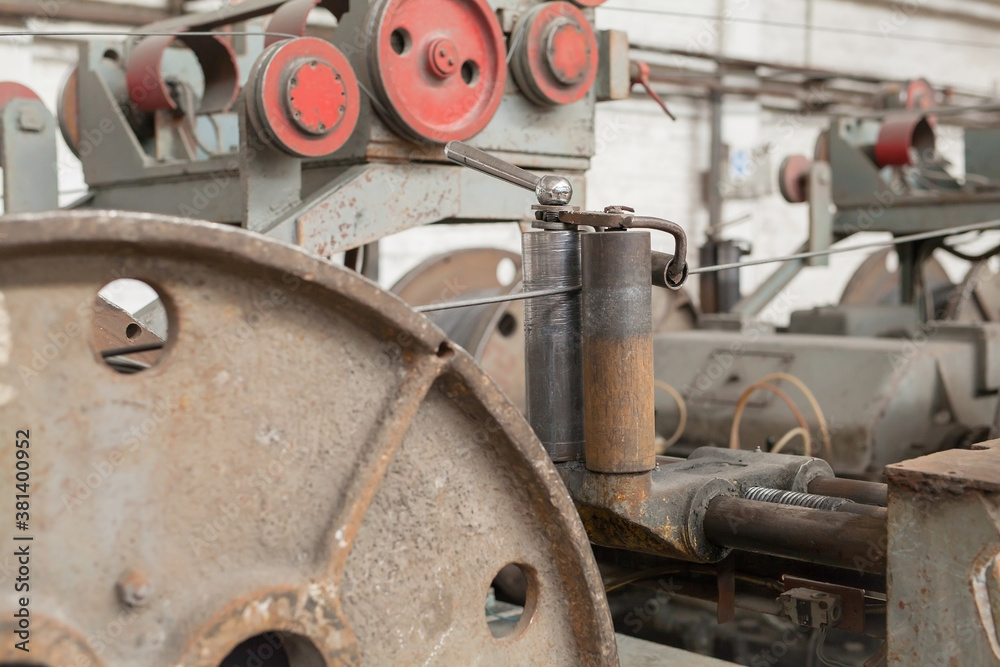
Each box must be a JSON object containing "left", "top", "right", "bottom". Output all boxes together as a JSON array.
[{"left": 366, "top": 0, "right": 507, "bottom": 143}]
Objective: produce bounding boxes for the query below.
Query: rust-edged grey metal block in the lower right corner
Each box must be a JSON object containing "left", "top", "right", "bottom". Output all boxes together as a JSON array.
[{"left": 886, "top": 441, "right": 1000, "bottom": 667}]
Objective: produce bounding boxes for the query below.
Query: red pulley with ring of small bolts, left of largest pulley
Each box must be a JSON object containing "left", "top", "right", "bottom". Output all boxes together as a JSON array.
[{"left": 247, "top": 37, "right": 361, "bottom": 157}]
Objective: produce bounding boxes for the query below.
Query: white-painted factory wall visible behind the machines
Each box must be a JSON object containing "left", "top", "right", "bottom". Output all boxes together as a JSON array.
[{"left": 0, "top": 0, "right": 1000, "bottom": 318}]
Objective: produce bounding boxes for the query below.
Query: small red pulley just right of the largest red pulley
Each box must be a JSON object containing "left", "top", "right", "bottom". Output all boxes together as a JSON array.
[{"left": 510, "top": 2, "right": 598, "bottom": 106}]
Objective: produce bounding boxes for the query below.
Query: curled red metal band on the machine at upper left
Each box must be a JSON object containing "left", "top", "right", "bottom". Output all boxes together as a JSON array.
[{"left": 126, "top": 34, "right": 240, "bottom": 114}]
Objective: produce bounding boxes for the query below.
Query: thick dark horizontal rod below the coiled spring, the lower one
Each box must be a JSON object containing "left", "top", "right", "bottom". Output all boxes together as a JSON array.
[{"left": 704, "top": 497, "right": 888, "bottom": 574}]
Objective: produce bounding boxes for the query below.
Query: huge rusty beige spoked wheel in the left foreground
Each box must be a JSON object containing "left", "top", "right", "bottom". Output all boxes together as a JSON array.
[{"left": 0, "top": 212, "right": 615, "bottom": 667}]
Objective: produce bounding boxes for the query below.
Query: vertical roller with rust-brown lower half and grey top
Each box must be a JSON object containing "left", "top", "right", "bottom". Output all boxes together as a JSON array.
[{"left": 581, "top": 231, "right": 656, "bottom": 473}]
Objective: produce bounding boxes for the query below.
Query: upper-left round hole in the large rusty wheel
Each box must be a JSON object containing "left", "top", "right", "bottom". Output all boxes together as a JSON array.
[{"left": 92, "top": 279, "right": 169, "bottom": 374}]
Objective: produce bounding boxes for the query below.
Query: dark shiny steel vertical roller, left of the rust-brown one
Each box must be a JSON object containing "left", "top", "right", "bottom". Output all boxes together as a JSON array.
[{"left": 521, "top": 230, "right": 584, "bottom": 461}]
